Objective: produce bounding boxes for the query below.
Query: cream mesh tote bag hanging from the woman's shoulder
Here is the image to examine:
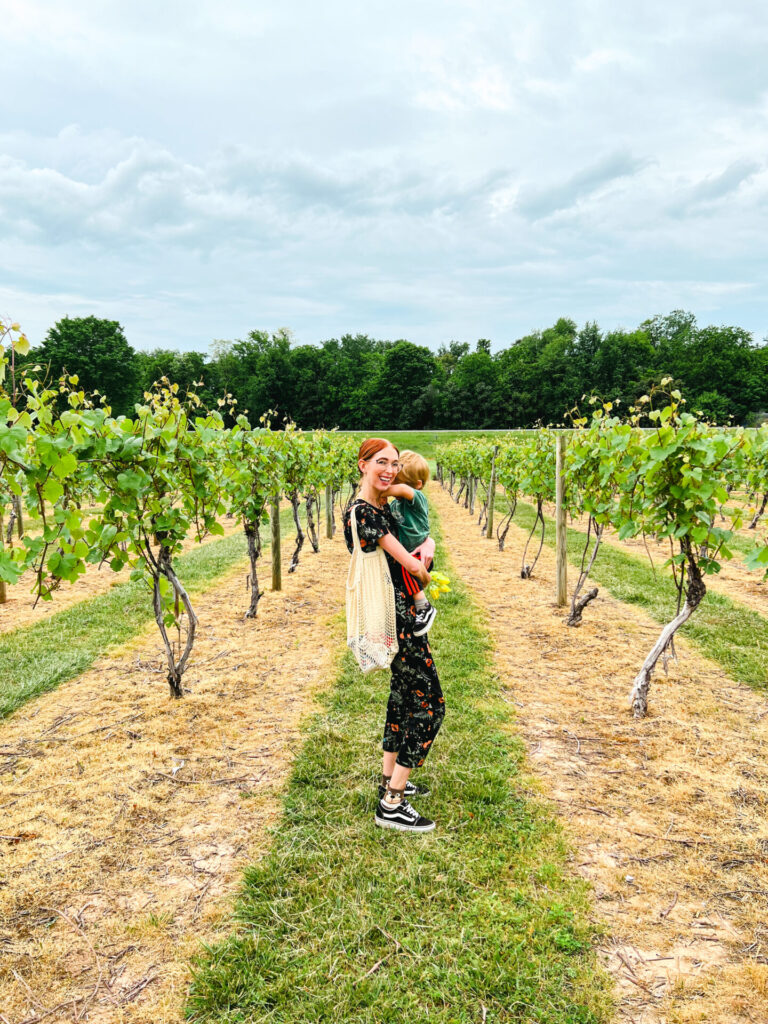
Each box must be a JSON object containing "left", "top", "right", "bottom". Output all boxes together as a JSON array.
[{"left": 347, "top": 508, "right": 397, "bottom": 672}]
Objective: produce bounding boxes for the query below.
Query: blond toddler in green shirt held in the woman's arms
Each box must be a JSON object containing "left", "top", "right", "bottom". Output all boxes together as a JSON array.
[{"left": 387, "top": 450, "right": 437, "bottom": 637}]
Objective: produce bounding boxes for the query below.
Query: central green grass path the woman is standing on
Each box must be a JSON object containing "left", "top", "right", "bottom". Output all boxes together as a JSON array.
[{"left": 187, "top": 516, "right": 610, "bottom": 1024}]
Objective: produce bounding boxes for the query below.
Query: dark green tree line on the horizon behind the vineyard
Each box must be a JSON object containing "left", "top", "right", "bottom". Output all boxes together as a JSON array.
[{"left": 26, "top": 310, "right": 768, "bottom": 430}]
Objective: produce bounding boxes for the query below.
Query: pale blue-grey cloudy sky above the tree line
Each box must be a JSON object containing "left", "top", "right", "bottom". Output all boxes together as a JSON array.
[{"left": 0, "top": 0, "right": 768, "bottom": 349}]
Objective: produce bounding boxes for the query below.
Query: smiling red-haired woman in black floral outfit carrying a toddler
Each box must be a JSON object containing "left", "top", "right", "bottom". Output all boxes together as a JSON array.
[{"left": 344, "top": 437, "right": 445, "bottom": 833}]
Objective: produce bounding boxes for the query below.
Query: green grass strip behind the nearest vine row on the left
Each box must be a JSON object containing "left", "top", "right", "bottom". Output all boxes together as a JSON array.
[{"left": 0, "top": 510, "right": 296, "bottom": 719}]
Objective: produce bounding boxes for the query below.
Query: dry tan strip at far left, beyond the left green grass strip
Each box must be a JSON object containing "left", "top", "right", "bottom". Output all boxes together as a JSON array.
[{"left": 0, "top": 518, "right": 243, "bottom": 633}]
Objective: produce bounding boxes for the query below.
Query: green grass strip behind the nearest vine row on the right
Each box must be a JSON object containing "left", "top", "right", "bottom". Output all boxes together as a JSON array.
[{"left": 497, "top": 495, "right": 768, "bottom": 690}]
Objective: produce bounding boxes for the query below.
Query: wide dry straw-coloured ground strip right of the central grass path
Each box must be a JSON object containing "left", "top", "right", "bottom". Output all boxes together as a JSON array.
[{"left": 431, "top": 486, "right": 768, "bottom": 1024}]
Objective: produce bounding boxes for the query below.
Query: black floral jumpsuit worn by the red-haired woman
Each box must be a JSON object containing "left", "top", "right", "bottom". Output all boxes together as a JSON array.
[{"left": 344, "top": 498, "right": 445, "bottom": 768}]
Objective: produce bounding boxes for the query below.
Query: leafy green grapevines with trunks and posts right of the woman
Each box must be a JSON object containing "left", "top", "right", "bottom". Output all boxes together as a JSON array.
[{"left": 437, "top": 381, "right": 768, "bottom": 718}]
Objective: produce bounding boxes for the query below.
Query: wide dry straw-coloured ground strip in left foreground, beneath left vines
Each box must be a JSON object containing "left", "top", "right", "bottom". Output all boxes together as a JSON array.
[{"left": 0, "top": 535, "right": 348, "bottom": 1024}]
